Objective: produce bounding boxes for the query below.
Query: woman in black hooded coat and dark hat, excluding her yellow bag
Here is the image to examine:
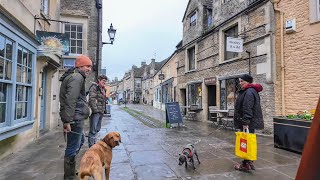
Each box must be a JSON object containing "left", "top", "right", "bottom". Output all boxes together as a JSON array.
[{"left": 234, "top": 74, "right": 264, "bottom": 171}]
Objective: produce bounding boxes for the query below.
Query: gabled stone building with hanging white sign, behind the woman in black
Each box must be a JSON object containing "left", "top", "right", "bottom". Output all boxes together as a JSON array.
[{"left": 177, "top": 0, "right": 275, "bottom": 133}]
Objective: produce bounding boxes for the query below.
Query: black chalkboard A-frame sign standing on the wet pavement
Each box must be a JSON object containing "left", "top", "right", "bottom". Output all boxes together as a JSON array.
[{"left": 166, "top": 102, "right": 182, "bottom": 124}]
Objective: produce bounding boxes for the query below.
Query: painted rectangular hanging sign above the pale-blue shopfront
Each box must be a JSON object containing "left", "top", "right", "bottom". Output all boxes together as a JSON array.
[{"left": 36, "top": 31, "right": 70, "bottom": 55}]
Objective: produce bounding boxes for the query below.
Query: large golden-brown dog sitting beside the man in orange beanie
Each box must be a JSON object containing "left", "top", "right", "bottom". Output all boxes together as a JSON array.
[{"left": 79, "top": 132, "right": 121, "bottom": 180}]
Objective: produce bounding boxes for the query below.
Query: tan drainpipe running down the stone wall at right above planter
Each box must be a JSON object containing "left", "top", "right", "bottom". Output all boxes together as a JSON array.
[{"left": 270, "top": 0, "right": 286, "bottom": 116}]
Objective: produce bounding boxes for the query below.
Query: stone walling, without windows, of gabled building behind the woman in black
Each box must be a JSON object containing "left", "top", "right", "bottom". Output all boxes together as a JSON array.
[{"left": 177, "top": 0, "right": 275, "bottom": 133}]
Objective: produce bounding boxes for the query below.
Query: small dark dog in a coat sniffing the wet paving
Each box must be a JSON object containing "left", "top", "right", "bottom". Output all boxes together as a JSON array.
[{"left": 179, "top": 144, "right": 200, "bottom": 169}]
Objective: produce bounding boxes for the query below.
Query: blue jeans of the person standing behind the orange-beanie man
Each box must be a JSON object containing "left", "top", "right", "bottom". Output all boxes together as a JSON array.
[{"left": 88, "top": 113, "right": 103, "bottom": 147}]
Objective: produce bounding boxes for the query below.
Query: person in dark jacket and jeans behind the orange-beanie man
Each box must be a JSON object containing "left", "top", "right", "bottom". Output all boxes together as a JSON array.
[{"left": 88, "top": 75, "right": 108, "bottom": 147}]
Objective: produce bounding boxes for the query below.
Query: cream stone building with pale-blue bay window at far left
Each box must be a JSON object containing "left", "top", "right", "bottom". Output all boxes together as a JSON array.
[{"left": 0, "top": 0, "right": 62, "bottom": 158}]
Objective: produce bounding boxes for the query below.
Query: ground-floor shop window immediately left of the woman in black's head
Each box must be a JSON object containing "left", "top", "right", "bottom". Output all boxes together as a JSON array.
[{"left": 220, "top": 78, "right": 241, "bottom": 109}]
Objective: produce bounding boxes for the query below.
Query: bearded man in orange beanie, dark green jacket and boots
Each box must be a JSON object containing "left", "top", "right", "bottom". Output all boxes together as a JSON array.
[{"left": 59, "top": 55, "right": 92, "bottom": 179}]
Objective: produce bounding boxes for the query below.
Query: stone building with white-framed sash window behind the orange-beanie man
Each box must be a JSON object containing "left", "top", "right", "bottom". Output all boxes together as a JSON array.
[{"left": 60, "top": 0, "right": 102, "bottom": 88}]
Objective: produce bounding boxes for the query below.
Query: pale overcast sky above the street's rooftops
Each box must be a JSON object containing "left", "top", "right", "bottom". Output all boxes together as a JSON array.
[{"left": 102, "top": 0, "right": 188, "bottom": 79}]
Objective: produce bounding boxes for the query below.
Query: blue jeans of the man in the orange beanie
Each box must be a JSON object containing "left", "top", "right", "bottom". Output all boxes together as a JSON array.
[{"left": 64, "top": 121, "right": 84, "bottom": 157}]
